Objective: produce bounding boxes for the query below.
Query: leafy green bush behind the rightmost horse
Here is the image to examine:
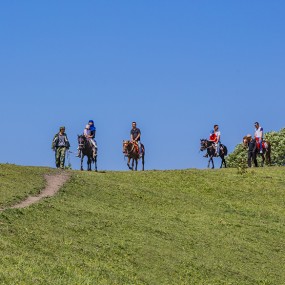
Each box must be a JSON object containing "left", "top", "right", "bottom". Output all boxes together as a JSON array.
[{"left": 226, "top": 128, "right": 285, "bottom": 168}]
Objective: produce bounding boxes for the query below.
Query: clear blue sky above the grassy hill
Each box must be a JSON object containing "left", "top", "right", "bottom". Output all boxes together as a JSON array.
[{"left": 0, "top": 0, "right": 285, "bottom": 170}]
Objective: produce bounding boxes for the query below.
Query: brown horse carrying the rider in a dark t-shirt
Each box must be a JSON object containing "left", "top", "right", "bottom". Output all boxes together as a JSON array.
[{"left": 123, "top": 140, "right": 145, "bottom": 170}]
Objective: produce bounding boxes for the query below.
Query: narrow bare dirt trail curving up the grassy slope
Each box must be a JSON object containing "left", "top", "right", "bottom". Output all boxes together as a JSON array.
[{"left": 0, "top": 173, "right": 70, "bottom": 211}]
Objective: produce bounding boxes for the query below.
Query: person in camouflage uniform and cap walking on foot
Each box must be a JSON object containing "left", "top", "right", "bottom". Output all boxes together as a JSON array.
[{"left": 51, "top": 127, "right": 70, "bottom": 169}]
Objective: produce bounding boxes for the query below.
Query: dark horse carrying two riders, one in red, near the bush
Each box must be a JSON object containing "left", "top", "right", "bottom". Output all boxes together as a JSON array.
[{"left": 200, "top": 139, "right": 228, "bottom": 169}]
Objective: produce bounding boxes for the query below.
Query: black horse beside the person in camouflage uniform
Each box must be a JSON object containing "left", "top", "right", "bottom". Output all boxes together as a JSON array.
[{"left": 77, "top": 135, "right": 97, "bottom": 171}]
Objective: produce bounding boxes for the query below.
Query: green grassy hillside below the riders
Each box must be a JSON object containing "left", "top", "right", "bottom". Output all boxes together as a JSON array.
[{"left": 0, "top": 165, "right": 285, "bottom": 285}]
